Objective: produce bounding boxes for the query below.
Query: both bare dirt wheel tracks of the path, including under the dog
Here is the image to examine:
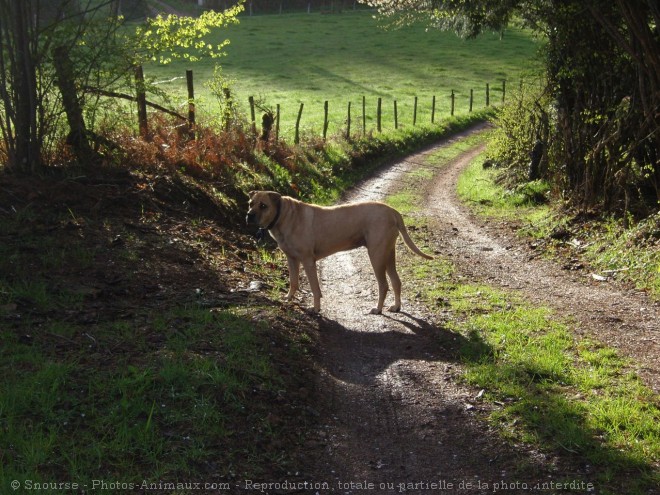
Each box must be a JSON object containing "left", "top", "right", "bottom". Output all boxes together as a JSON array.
[{"left": 305, "top": 127, "right": 660, "bottom": 494}]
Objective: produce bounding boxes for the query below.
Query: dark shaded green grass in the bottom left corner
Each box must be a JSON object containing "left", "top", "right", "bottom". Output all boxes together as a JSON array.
[{"left": 0, "top": 308, "right": 279, "bottom": 480}]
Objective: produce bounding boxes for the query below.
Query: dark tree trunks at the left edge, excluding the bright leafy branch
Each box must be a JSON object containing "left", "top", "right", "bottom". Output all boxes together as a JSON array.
[{"left": 0, "top": 0, "right": 133, "bottom": 173}]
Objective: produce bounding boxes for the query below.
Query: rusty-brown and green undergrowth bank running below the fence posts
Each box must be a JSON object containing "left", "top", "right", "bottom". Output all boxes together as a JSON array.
[{"left": 104, "top": 109, "right": 493, "bottom": 207}]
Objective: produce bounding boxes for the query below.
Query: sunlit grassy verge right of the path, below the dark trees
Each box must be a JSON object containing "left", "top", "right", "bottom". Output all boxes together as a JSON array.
[{"left": 458, "top": 159, "right": 660, "bottom": 300}]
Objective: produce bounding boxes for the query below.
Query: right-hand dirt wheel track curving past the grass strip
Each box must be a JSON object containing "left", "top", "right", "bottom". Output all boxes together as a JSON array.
[{"left": 428, "top": 144, "right": 660, "bottom": 392}]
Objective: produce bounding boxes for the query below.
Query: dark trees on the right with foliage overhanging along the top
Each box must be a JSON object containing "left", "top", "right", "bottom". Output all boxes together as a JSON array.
[{"left": 368, "top": 0, "right": 660, "bottom": 211}]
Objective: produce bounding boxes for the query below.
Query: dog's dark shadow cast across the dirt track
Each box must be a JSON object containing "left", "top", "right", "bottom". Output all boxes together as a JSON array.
[{"left": 319, "top": 312, "right": 490, "bottom": 385}]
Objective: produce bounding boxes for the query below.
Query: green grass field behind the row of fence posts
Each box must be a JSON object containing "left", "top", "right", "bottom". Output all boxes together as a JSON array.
[{"left": 146, "top": 11, "right": 538, "bottom": 140}]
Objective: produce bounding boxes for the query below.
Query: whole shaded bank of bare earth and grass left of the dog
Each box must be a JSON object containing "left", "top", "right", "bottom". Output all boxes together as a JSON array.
[{"left": 0, "top": 172, "right": 318, "bottom": 493}]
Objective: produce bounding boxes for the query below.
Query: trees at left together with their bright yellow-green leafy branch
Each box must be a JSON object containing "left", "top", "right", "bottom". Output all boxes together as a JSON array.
[{"left": 0, "top": 0, "right": 242, "bottom": 173}]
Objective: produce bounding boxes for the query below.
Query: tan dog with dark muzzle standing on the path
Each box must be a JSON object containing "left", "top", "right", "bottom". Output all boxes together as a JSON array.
[{"left": 246, "top": 191, "right": 433, "bottom": 314}]
